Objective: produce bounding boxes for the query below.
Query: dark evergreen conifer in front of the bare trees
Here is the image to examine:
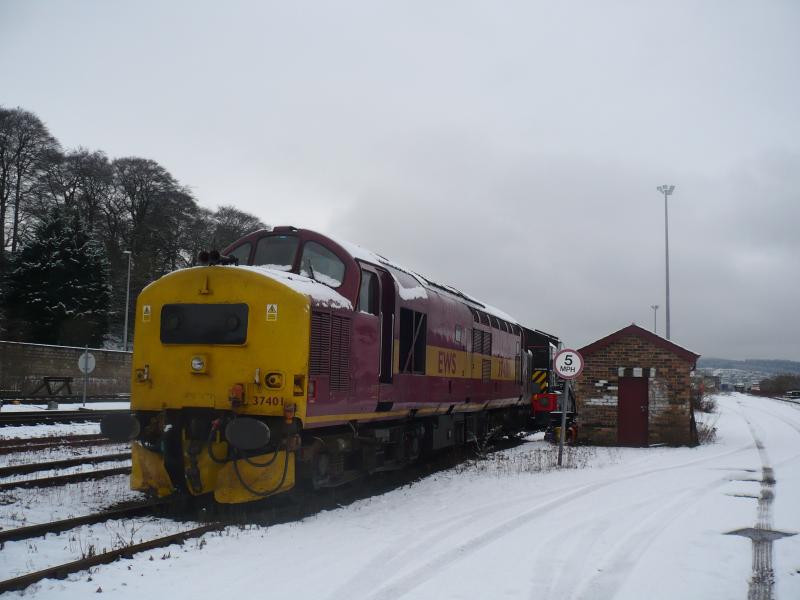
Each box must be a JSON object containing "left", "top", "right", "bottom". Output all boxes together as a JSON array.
[{"left": 3, "top": 210, "right": 111, "bottom": 346}]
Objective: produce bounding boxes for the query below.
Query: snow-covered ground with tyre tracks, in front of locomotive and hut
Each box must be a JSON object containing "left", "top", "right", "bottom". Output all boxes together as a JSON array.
[{"left": 0, "top": 394, "right": 800, "bottom": 600}]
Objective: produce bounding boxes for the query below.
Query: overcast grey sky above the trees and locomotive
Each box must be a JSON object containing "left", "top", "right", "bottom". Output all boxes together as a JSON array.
[{"left": 0, "top": 0, "right": 800, "bottom": 360}]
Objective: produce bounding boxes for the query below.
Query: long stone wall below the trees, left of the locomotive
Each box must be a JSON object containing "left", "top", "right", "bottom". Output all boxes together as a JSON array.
[{"left": 0, "top": 341, "right": 131, "bottom": 396}]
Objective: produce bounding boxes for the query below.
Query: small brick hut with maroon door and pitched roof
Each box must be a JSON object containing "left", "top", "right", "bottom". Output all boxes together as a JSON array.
[{"left": 575, "top": 325, "right": 700, "bottom": 446}]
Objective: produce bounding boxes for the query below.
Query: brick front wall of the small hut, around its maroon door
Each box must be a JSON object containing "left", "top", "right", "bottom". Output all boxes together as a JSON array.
[{"left": 575, "top": 335, "right": 694, "bottom": 446}]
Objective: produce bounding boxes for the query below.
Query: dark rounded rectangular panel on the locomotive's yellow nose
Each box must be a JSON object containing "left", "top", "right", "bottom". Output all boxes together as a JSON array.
[{"left": 161, "top": 304, "right": 247, "bottom": 345}]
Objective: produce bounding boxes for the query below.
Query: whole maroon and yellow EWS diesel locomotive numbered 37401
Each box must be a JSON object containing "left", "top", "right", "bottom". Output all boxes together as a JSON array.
[{"left": 102, "top": 227, "right": 557, "bottom": 503}]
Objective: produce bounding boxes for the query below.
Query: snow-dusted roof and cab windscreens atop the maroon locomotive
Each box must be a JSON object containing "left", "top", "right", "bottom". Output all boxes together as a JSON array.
[{"left": 223, "top": 226, "right": 518, "bottom": 324}]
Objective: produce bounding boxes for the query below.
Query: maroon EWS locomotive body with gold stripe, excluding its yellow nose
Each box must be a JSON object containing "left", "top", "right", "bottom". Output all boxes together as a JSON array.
[{"left": 224, "top": 227, "right": 531, "bottom": 485}]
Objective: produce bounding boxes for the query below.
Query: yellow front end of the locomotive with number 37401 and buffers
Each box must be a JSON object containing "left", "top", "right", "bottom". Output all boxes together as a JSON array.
[{"left": 111, "top": 266, "right": 310, "bottom": 503}]
